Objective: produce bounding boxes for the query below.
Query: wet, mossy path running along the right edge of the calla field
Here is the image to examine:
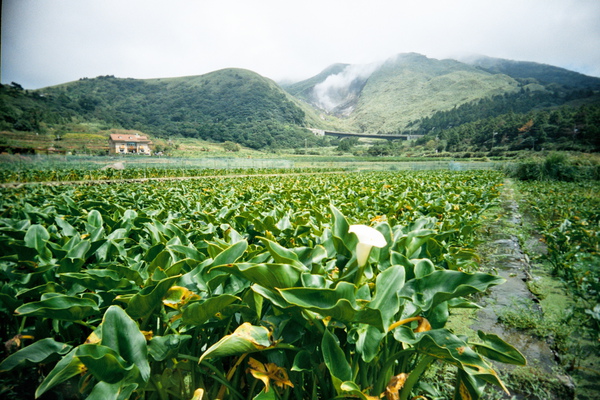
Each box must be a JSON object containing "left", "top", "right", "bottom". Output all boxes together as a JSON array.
[{"left": 471, "top": 181, "right": 575, "bottom": 400}]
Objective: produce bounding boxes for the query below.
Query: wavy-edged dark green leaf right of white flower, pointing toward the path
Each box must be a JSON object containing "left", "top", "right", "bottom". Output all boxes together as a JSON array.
[{"left": 399, "top": 270, "right": 505, "bottom": 311}]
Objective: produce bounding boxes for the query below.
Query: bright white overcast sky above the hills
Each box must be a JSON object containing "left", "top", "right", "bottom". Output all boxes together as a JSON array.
[{"left": 1, "top": 0, "right": 600, "bottom": 89}]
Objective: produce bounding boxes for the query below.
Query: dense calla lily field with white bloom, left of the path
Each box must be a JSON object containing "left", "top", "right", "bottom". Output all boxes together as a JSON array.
[{"left": 0, "top": 171, "right": 525, "bottom": 400}]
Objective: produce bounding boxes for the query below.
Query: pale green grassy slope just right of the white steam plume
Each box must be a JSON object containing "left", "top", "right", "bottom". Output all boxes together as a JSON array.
[{"left": 349, "top": 54, "right": 518, "bottom": 132}]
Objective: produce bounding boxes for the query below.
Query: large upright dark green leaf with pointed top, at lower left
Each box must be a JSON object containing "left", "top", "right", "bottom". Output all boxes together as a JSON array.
[{"left": 101, "top": 306, "right": 150, "bottom": 381}]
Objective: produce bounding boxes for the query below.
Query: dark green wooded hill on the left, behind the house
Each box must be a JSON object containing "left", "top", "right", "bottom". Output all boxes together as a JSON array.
[{"left": 0, "top": 69, "right": 336, "bottom": 149}]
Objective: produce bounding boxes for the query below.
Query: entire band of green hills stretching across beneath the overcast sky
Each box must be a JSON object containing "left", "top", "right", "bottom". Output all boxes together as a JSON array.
[{"left": 0, "top": 53, "right": 600, "bottom": 155}]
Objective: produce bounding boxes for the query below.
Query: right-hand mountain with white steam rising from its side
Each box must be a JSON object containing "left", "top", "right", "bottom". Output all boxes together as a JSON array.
[{"left": 286, "top": 53, "right": 600, "bottom": 133}]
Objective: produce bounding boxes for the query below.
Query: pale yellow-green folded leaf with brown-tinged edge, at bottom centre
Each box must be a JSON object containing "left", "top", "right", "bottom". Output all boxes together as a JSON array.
[{"left": 199, "top": 322, "right": 272, "bottom": 362}]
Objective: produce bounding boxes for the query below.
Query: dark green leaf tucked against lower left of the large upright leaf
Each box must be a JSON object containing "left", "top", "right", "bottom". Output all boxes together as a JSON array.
[{"left": 75, "top": 338, "right": 133, "bottom": 383}]
